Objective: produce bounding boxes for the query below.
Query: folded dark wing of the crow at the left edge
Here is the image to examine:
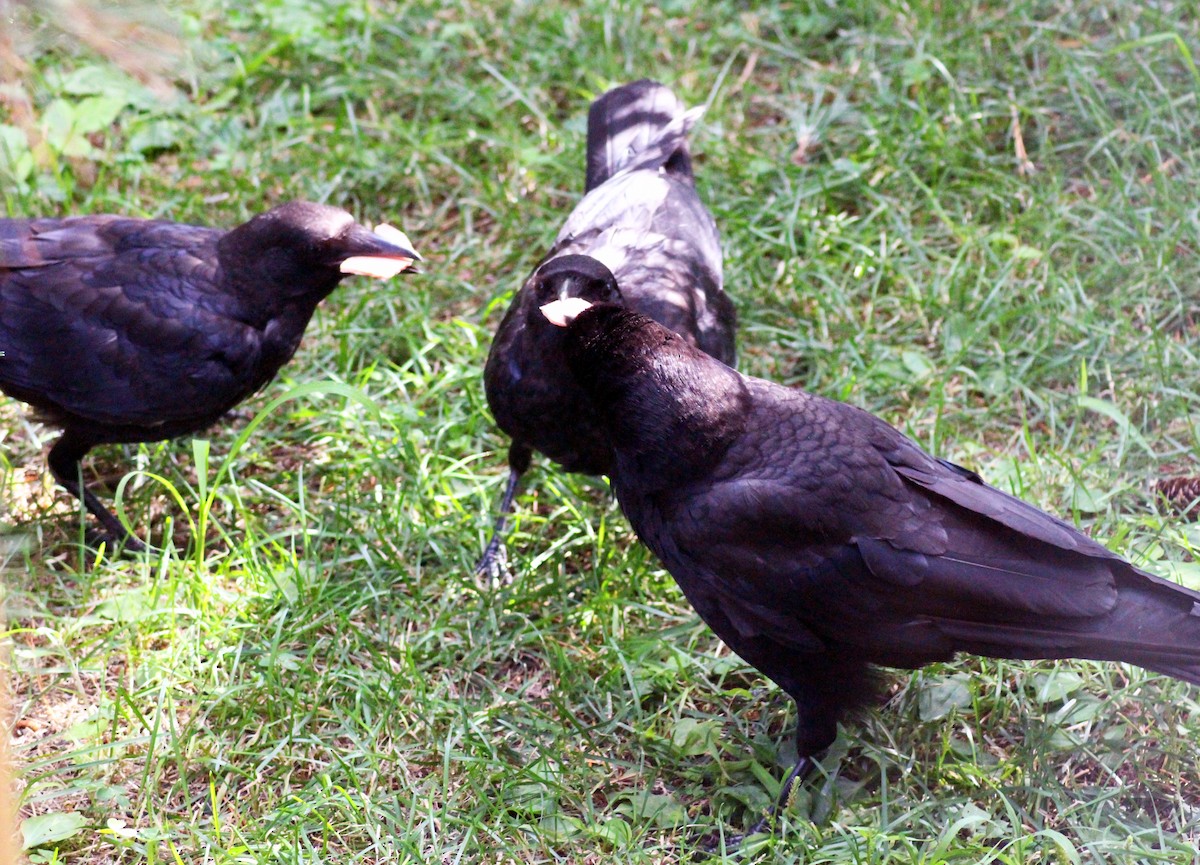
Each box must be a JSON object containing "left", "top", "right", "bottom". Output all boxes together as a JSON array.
[{"left": 0, "top": 217, "right": 267, "bottom": 427}]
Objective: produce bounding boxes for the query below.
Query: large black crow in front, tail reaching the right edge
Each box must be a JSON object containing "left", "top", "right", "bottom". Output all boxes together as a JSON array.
[{"left": 545, "top": 299, "right": 1200, "bottom": 830}]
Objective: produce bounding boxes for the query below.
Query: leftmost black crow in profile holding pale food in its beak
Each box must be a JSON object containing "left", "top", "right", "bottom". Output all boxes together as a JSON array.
[{"left": 0, "top": 202, "right": 419, "bottom": 549}]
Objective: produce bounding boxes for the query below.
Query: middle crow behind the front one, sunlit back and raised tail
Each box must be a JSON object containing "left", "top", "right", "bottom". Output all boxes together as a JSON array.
[{"left": 476, "top": 79, "right": 737, "bottom": 573}]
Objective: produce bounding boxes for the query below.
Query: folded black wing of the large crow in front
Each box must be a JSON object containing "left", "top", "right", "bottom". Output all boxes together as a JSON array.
[{"left": 664, "top": 383, "right": 1135, "bottom": 650}]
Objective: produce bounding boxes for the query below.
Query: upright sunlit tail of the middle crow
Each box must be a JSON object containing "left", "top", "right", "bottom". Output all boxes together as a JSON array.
[{"left": 587, "top": 78, "right": 703, "bottom": 192}]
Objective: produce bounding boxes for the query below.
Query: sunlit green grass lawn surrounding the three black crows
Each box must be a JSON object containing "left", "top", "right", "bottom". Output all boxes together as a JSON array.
[{"left": 0, "top": 0, "right": 1200, "bottom": 865}]
